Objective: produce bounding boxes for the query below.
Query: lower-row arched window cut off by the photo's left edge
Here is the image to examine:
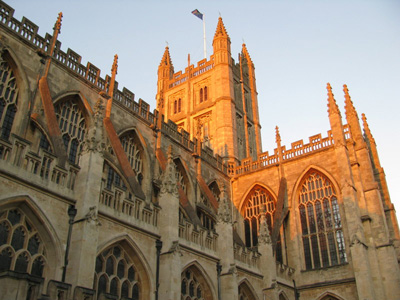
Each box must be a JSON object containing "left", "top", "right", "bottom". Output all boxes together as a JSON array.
[{"left": 0, "top": 209, "right": 46, "bottom": 277}]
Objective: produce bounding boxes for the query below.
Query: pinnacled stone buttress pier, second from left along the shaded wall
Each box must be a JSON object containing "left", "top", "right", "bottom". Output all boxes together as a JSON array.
[{"left": 159, "top": 146, "right": 182, "bottom": 300}]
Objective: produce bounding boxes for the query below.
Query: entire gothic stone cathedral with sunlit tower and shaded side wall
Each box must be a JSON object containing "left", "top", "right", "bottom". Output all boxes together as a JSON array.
[{"left": 0, "top": 1, "right": 400, "bottom": 300}]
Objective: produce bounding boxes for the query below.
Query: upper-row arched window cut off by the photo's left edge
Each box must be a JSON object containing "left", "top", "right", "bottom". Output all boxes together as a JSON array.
[{"left": 0, "top": 56, "right": 18, "bottom": 140}]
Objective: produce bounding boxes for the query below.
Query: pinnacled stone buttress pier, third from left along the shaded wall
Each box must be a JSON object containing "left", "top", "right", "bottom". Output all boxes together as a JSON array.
[{"left": 215, "top": 185, "right": 238, "bottom": 300}]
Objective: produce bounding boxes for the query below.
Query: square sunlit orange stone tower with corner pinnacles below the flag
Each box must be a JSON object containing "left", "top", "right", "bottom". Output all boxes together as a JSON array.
[{"left": 156, "top": 18, "right": 262, "bottom": 165}]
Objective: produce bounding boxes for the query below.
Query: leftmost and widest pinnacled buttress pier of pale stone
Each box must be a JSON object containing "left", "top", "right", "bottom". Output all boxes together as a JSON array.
[{"left": 66, "top": 98, "right": 105, "bottom": 289}]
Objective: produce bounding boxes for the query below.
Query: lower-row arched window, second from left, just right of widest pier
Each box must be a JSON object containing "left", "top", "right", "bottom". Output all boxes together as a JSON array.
[{"left": 94, "top": 245, "right": 141, "bottom": 300}]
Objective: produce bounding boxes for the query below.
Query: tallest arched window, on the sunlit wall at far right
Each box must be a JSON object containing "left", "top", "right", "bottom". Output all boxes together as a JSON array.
[{"left": 299, "top": 171, "right": 347, "bottom": 270}]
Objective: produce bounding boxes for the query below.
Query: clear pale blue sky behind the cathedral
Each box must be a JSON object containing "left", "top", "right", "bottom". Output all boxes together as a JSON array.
[{"left": 6, "top": 0, "right": 400, "bottom": 220}]
